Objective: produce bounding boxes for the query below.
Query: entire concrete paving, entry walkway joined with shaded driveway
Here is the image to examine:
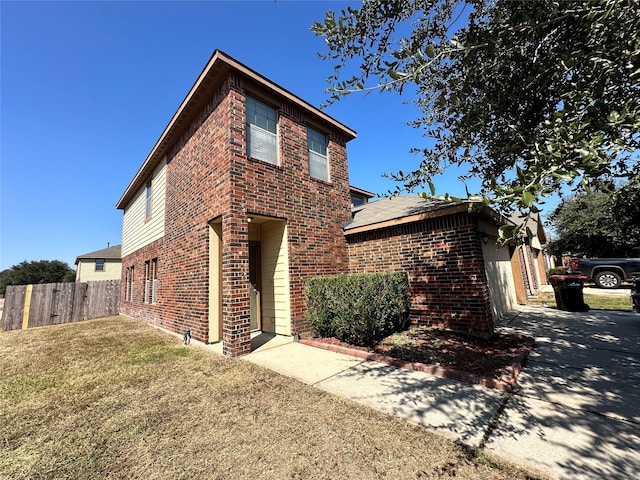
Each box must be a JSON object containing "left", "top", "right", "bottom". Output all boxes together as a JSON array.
[{"left": 243, "top": 308, "right": 640, "bottom": 479}]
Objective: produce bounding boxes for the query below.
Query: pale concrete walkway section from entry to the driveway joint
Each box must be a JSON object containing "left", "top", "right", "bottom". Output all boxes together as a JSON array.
[{"left": 243, "top": 342, "right": 505, "bottom": 446}]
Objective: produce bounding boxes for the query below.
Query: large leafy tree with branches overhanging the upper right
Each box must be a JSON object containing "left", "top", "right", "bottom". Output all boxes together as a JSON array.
[{"left": 312, "top": 0, "right": 640, "bottom": 238}]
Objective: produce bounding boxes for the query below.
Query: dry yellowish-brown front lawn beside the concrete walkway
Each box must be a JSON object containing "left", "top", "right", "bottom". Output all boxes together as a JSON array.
[{"left": 0, "top": 317, "right": 544, "bottom": 479}]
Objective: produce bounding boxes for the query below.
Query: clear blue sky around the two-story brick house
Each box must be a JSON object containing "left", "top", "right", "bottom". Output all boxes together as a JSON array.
[{"left": 0, "top": 0, "right": 490, "bottom": 270}]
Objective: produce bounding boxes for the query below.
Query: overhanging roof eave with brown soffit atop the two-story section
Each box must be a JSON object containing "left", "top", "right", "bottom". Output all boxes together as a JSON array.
[{"left": 116, "top": 50, "right": 356, "bottom": 209}]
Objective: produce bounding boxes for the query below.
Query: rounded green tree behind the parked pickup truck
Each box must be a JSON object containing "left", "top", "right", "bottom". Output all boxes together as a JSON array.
[{"left": 549, "top": 187, "right": 640, "bottom": 257}]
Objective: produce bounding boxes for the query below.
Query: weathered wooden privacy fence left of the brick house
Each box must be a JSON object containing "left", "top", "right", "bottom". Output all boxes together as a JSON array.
[{"left": 2, "top": 280, "right": 120, "bottom": 331}]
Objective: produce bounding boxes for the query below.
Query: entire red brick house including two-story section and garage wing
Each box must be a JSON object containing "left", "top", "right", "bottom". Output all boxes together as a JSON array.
[{"left": 117, "top": 51, "right": 513, "bottom": 356}]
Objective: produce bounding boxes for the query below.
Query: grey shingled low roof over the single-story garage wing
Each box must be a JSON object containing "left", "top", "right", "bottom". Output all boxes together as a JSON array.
[{"left": 343, "top": 195, "right": 469, "bottom": 235}]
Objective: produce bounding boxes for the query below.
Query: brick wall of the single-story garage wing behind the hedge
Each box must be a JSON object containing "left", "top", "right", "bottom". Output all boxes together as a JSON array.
[{"left": 347, "top": 214, "right": 493, "bottom": 334}]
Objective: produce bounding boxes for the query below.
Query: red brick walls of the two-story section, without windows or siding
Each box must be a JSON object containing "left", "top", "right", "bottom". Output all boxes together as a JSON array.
[{"left": 122, "top": 71, "right": 350, "bottom": 357}]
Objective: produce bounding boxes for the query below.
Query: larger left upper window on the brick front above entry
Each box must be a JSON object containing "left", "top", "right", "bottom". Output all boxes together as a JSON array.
[{"left": 247, "top": 97, "right": 278, "bottom": 165}]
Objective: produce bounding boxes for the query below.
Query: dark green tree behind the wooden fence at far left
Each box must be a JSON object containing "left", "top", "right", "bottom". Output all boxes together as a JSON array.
[{"left": 0, "top": 260, "right": 75, "bottom": 295}]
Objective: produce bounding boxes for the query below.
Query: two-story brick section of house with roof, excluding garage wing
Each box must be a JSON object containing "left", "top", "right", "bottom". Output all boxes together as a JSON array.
[{"left": 117, "top": 51, "right": 356, "bottom": 356}]
